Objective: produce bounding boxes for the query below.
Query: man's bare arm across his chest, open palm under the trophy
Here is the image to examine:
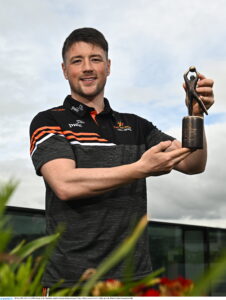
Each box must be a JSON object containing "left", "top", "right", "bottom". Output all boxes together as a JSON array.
[{"left": 41, "top": 141, "right": 191, "bottom": 200}]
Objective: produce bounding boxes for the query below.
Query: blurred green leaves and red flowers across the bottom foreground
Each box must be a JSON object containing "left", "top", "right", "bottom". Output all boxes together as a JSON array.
[{"left": 0, "top": 180, "right": 226, "bottom": 296}]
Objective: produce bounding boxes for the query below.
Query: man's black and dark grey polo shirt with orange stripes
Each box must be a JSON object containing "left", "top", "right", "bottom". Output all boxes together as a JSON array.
[{"left": 30, "top": 96, "right": 173, "bottom": 287}]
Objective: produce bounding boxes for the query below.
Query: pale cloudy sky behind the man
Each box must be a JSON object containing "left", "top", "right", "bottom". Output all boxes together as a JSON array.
[{"left": 0, "top": 0, "right": 226, "bottom": 228}]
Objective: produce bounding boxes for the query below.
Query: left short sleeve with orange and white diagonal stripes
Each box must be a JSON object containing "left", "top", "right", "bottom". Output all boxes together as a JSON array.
[{"left": 30, "top": 111, "right": 75, "bottom": 176}]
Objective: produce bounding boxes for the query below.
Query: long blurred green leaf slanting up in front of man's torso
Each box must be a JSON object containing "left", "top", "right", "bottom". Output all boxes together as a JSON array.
[{"left": 80, "top": 215, "right": 147, "bottom": 296}]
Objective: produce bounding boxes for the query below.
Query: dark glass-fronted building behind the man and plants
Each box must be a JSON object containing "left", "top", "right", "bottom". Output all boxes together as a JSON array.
[{"left": 6, "top": 206, "right": 226, "bottom": 296}]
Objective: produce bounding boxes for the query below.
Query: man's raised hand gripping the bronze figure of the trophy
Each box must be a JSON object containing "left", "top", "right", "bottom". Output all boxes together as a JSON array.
[{"left": 183, "top": 73, "right": 214, "bottom": 116}]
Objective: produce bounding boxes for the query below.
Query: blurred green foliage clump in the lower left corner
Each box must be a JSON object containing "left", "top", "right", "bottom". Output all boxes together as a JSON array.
[{"left": 0, "top": 180, "right": 60, "bottom": 296}]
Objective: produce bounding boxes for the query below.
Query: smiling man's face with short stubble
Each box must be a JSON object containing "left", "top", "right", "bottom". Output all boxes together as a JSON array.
[{"left": 62, "top": 42, "right": 110, "bottom": 101}]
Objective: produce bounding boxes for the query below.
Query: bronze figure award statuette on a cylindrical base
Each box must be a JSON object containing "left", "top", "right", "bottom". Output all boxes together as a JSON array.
[{"left": 182, "top": 67, "right": 208, "bottom": 150}]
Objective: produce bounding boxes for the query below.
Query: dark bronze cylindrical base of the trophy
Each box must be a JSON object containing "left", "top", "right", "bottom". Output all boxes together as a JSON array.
[{"left": 182, "top": 116, "right": 204, "bottom": 149}]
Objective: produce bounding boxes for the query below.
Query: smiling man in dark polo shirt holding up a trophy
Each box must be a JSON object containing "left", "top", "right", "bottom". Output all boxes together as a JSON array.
[{"left": 30, "top": 28, "right": 213, "bottom": 287}]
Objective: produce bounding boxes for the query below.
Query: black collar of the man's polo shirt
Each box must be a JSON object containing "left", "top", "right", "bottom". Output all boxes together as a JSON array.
[{"left": 63, "top": 95, "right": 113, "bottom": 117}]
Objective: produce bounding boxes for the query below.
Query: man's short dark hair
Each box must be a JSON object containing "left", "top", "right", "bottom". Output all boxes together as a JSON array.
[{"left": 62, "top": 27, "right": 108, "bottom": 60}]
